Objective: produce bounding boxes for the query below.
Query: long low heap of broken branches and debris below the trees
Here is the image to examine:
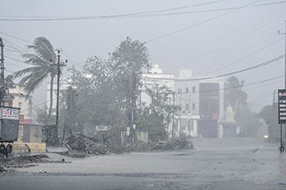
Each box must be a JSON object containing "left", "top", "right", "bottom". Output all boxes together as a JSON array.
[{"left": 62, "top": 134, "right": 193, "bottom": 157}]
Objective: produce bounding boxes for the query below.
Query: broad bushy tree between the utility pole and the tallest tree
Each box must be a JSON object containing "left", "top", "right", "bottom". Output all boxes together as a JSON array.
[{"left": 67, "top": 57, "right": 127, "bottom": 130}]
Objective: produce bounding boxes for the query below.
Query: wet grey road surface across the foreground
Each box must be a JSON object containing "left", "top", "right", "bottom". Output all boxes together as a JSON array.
[{"left": 0, "top": 138, "right": 286, "bottom": 190}]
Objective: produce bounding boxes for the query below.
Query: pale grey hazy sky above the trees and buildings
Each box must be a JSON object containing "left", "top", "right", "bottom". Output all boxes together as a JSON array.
[{"left": 0, "top": 0, "right": 286, "bottom": 109}]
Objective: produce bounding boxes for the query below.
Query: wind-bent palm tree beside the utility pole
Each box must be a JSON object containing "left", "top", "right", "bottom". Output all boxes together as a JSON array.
[{"left": 13, "top": 37, "right": 57, "bottom": 117}]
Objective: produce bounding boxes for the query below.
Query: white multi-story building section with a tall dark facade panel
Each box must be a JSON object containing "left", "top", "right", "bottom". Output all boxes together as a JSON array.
[{"left": 175, "top": 70, "right": 225, "bottom": 137}]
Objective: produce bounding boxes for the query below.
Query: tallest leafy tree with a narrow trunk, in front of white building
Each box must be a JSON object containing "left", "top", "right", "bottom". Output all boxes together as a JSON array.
[{"left": 111, "top": 37, "right": 151, "bottom": 138}]
